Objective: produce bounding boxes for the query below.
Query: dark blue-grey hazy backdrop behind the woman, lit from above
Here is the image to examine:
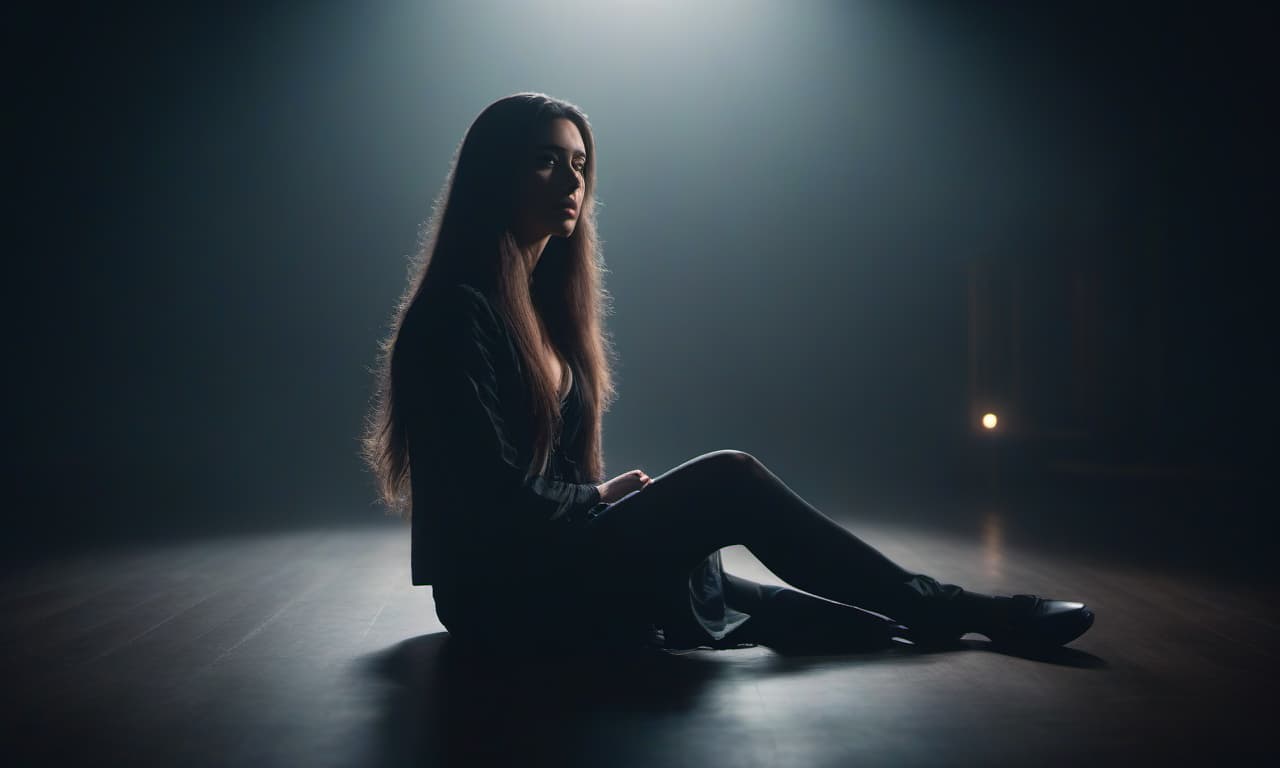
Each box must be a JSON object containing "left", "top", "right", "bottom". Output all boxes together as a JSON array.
[{"left": 4, "top": 3, "right": 1276, "bottom": 563}]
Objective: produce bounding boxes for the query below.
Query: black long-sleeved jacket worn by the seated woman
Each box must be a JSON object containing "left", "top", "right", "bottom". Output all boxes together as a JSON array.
[{"left": 407, "top": 284, "right": 603, "bottom": 586}]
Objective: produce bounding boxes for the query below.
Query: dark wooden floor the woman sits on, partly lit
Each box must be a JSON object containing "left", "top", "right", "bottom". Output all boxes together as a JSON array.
[{"left": 0, "top": 506, "right": 1280, "bottom": 768}]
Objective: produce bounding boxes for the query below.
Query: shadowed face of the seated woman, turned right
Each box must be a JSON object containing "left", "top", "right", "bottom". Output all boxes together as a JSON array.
[{"left": 515, "top": 118, "right": 586, "bottom": 242}]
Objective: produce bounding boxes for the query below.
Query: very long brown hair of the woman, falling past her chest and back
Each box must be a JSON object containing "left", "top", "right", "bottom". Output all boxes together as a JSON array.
[{"left": 361, "top": 93, "right": 616, "bottom": 520}]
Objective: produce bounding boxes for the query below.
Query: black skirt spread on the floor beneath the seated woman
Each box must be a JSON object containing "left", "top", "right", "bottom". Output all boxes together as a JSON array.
[{"left": 433, "top": 503, "right": 750, "bottom": 653}]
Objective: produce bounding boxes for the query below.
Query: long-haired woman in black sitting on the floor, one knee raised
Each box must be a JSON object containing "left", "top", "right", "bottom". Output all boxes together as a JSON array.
[{"left": 364, "top": 93, "right": 1093, "bottom": 649}]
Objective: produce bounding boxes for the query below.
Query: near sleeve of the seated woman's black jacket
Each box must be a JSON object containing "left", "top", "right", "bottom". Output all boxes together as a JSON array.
[{"left": 430, "top": 284, "right": 600, "bottom": 521}]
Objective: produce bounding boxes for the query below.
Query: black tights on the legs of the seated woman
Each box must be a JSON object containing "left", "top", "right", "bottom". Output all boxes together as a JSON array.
[{"left": 590, "top": 451, "right": 957, "bottom": 641}]
